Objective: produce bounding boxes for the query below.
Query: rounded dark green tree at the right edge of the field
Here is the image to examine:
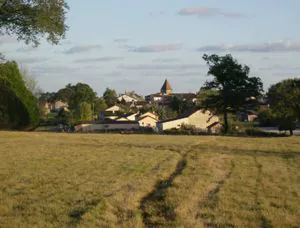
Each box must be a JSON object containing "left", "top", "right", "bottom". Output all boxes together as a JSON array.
[{"left": 267, "top": 78, "right": 300, "bottom": 135}]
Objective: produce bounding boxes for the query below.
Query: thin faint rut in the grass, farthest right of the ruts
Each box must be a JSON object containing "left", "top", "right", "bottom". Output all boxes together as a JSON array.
[{"left": 254, "top": 156, "right": 273, "bottom": 228}]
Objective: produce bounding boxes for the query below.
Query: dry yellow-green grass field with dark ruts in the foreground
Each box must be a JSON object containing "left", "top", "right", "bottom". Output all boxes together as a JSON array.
[{"left": 0, "top": 132, "right": 300, "bottom": 228}]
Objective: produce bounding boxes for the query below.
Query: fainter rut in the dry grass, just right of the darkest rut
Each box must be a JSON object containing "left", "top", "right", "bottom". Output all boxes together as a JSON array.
[{"left": 196, "top": 161, "right": 235, "bottom": 227}]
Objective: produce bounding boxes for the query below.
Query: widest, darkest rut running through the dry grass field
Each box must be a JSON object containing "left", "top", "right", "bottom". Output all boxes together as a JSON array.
[{"left": 140, "top": 153, "right": 187, "bottom": 227}]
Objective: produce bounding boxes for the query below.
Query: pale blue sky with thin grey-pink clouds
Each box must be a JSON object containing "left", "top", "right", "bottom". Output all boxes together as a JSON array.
[{"left": 0, "top": 0, "right": 300, "bottom": 95}]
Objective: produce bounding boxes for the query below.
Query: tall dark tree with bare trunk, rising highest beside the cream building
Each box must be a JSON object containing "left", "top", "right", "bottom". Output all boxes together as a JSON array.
[{"left": 202, "top": 54, "right": 263, "bottom": 133}]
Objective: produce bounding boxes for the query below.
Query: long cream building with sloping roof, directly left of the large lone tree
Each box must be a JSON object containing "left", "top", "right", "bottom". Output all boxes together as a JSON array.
[{"left": 157, "top": 110, "right": 221, "bottom": 133}]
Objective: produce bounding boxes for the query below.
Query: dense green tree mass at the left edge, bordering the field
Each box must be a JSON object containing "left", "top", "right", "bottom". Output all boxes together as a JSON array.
[{"left": 0, "top": 62, "right": 39, "bottom": 130}]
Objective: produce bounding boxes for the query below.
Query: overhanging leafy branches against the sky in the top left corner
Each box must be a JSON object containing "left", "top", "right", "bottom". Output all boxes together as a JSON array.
[{"left": 0, "top": 0, "right": 68, "bottom": 45}]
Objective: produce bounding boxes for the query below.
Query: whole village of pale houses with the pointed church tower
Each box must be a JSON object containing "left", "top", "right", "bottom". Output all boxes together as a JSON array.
[{"left": 39, "top": 80, "right": 268, "bottom": 133}]
